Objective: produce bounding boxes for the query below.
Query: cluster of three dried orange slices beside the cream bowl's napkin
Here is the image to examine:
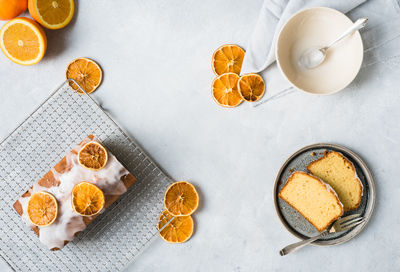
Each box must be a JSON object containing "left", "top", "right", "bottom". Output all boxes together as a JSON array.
[{"left": 211, "top": 44, "right": 265, "bottom": 108}]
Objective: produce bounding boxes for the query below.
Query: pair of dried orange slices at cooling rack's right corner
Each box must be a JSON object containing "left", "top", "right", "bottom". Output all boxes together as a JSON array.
[{"left": 157, "top": 181, "right": 199, "bottom": 243}]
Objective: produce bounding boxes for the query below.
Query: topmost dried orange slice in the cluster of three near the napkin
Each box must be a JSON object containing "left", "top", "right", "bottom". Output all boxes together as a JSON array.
[{"left": 212, "top": 44, "right": 245, "bottom": 76}]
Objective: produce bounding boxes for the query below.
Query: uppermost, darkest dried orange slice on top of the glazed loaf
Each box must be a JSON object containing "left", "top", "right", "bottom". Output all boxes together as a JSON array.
[{"left": 78, "top": 142, "right": 108, "bottom": 171}]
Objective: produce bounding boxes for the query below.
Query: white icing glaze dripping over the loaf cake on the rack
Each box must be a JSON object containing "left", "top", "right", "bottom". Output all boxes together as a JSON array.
[{"left": 19, "top": 138, "right": 129, "bottom": 249}]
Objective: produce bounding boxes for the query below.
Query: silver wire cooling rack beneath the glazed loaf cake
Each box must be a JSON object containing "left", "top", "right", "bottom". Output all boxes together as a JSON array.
[{"left": 0, "top": 81, "right": 172, "bottom": 271}]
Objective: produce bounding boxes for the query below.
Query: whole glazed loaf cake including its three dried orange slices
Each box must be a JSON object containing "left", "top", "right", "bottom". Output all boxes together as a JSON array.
[{"left": 14, "top": 135, "right": 136, "bottom": 250}]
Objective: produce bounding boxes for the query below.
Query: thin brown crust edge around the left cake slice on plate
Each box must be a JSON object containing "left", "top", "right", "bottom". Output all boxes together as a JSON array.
[{"left": 278, "top": 171, "right": 344, "bottom": 232}]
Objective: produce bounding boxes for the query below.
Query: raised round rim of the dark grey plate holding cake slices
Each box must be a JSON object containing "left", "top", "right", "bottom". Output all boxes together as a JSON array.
[{"left": 273, "top": 143, "right": 376, "bottom": 246}]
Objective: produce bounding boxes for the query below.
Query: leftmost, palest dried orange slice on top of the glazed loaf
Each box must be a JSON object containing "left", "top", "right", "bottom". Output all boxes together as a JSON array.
[{"left": 27, "top": 191, "right": 58, "bottom": 227}]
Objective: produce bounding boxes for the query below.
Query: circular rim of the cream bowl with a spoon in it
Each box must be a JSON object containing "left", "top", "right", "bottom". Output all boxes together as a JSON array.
[{"left": 275, "top": 7, "right": 364, "bottom": 96}]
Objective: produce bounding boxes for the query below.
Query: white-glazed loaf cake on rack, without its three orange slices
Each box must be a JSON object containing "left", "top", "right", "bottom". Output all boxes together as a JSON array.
[{"left": 14, "top": 135, "right": 136, "bottom": 250}]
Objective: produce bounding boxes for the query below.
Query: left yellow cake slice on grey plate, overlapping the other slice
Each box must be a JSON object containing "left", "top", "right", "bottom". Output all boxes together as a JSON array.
[{"left": 279, "top": 171, "right": 343, "bottom": 232}]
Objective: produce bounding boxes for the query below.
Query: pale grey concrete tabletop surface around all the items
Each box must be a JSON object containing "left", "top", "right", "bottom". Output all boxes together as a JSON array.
[{"left": 0, "top": 0, "right": 400, "bottom": 271}]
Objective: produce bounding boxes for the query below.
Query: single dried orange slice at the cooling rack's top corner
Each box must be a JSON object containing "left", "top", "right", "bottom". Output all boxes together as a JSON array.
[{"left": 65, "top": 58, "right": 103, "bottom": 94}]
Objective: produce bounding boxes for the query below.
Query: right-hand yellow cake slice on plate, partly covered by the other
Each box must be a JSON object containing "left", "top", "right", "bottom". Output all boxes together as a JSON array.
[{"left": 307, "top": 151, "right": 363, "bottom": 211}]
